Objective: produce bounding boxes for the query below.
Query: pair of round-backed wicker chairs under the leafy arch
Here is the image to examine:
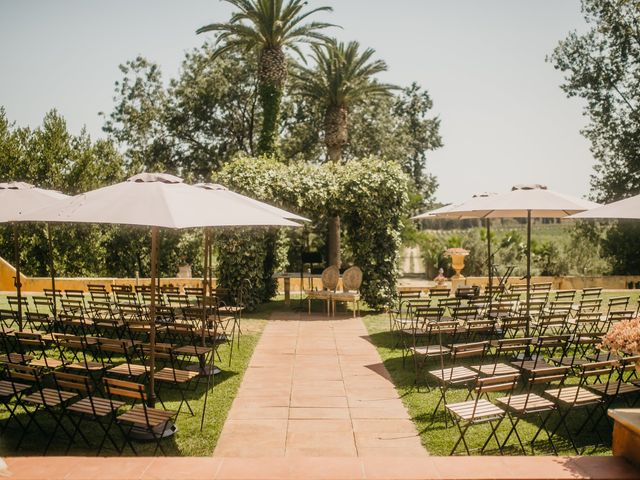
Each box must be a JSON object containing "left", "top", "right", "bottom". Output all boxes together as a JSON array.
[{"left": 306, "top": 266, "right": 362, "bottom": 318}]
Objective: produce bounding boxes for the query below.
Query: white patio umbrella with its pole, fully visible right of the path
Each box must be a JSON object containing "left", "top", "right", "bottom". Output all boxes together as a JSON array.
[{"left": 424, "top": 185, "right": 599, "bottom": 334}]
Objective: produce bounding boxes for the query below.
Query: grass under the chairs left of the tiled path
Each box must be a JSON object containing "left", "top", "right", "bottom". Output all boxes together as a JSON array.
[{"left": 0, "top": 298, "right": 275, "bottom": 457}]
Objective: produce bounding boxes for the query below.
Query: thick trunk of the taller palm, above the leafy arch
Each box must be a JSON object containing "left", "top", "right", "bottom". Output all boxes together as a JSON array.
[{"left": 258, "top": 48, "right": 287, "bottom": 155}]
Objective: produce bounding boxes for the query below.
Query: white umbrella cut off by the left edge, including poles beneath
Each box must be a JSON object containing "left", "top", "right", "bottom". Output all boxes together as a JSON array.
[{"left": 0, "top": 182, "right": 69, "bottom": 330}]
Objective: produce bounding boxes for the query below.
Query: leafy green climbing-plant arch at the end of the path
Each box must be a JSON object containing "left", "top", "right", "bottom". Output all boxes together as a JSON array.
[{"left": 216, "top": 157, "right": 407, "bottom": 308}]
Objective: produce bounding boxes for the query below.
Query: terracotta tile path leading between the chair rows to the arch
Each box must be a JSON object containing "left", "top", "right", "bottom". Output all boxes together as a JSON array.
[{"left": 214, "top": 313, "right": 427, "bottom": 458}]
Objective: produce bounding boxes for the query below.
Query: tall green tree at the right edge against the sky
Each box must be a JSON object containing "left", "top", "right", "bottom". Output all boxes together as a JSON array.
[{"left": 550, "top": 0, "right": 640, "bottom": 273}]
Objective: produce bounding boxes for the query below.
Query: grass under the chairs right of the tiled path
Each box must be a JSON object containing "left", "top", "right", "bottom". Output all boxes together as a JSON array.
[{"left": 363, "top": 291, "right": 638, "bottom": 455}]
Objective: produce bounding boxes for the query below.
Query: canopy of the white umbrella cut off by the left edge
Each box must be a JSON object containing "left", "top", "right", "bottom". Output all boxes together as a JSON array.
[{"left": 0, "top": 182, "right": 68, "bottom": 223}]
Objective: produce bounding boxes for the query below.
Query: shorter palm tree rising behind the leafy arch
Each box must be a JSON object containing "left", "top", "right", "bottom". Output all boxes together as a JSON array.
[{"left": 294, "top": 39, "right": 396, "bottom": 267}]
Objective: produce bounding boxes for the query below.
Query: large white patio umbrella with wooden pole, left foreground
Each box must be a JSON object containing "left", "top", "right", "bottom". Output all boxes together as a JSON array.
[{"left": 23, "top": 173, "right": 299, "bottom": 406}]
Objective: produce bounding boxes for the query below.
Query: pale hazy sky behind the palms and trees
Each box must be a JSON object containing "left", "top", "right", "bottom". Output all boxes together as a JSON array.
[{"left": 0, "top": 0, "right": 594, "bottom": 202}]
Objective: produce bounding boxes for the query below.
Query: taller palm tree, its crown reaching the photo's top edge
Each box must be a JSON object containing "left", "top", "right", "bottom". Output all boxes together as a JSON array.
[{"left": 196, "top": 0, "right": 334, "bottom": 154}]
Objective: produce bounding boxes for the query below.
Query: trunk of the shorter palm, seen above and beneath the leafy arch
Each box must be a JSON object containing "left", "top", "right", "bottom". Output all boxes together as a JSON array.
[{"left": 324, "top": 106, "right": 348, "bottom": 268}]
